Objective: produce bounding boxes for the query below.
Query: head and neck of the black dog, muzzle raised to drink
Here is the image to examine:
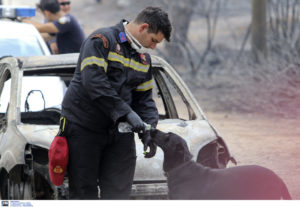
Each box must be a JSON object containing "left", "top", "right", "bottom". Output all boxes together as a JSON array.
[{"left": 151, "top": 129, "right": 192, "bottom": 172}]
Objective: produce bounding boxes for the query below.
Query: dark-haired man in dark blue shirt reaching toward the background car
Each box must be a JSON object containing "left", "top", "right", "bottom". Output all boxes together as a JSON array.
[{"left": 22, "top": 0, "right": 85, "bottom": 54}]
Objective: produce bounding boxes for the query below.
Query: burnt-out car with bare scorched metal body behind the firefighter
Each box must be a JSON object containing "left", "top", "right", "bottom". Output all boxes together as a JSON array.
[{"left": 0, "top": 54, "right": 234, "bottom": 200}]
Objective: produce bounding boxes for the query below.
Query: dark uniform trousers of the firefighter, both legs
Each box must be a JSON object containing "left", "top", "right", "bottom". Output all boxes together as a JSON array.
[{"left": 65, "top": 121, "right": 136, "bottom": 200}]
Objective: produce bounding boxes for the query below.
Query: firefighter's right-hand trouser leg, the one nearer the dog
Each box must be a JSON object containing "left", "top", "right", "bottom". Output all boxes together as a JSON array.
[{"left": 99, "top": 132, "right": 136, "bottom": 199}]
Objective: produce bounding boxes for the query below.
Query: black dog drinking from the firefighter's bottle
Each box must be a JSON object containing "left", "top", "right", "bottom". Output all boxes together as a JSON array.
[{"left": 151, "top": 130, "right": 291, "bottom": 200}]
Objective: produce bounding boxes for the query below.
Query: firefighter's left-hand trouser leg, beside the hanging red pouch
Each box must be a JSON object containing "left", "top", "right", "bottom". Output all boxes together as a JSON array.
[{"left": 66, "top": 122, "right": 108, "bottom": 200}]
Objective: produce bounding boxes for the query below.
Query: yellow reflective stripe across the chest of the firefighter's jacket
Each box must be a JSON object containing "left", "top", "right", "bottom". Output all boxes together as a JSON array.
[{"left": 107, "top": 52, "right": 150, "bottom": 73}]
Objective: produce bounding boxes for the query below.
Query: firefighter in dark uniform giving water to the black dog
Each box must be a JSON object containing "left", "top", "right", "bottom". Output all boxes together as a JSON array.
[{"left": 62, "top": 7, "right": 172, "bottom": 199}]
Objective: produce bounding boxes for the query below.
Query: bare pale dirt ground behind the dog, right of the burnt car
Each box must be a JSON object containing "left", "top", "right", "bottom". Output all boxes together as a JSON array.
[{"left": 206, "top": 112, "right": 300, "bottom": 200}]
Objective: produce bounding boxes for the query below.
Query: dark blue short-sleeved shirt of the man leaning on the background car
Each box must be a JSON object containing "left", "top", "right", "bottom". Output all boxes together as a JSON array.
[{"left": 53, "top": 14, "right": 84, "bottom": 54}]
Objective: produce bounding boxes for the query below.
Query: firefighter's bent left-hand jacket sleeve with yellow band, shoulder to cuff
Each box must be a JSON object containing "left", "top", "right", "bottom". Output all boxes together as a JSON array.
[{"left": 79, "top": 36, "right": 132, "bottom": 121}]
